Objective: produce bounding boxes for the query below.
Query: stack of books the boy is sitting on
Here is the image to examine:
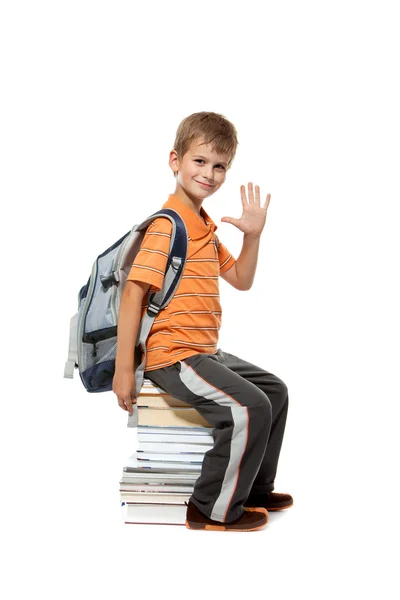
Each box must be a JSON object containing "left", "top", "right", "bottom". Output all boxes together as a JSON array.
[{"left": 120, "top": 379, "right": 214, "bottom": 525}]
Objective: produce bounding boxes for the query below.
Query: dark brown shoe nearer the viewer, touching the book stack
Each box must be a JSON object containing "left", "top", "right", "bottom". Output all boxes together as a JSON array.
[{"left": 185, "top": 500, "right": 268, "bottom": 531}]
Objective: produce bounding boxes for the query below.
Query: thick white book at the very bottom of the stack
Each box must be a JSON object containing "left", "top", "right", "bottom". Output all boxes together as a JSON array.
[{"left": 123, "top": 504, "right": 187, "bottom": 525}]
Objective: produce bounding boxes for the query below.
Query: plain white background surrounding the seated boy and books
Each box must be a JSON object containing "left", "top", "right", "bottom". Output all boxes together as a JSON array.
[{"left": 0, "top": 0, "right": 400, "bottom": 599}]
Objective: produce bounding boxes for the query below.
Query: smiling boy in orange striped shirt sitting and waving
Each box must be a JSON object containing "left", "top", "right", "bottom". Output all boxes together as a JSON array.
[{"left": 113, "top": 112, "right": 293, "bottom": 531}]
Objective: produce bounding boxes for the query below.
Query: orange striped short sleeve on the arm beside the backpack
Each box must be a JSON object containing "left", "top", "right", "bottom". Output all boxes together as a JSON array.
[{"left": 127, "top": 218, "right": 172, "bottom": 290}]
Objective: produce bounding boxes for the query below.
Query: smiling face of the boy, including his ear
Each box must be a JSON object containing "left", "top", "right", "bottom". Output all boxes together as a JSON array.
[{"left": 169, "top": 137, "right": 229, "bottom": 200}]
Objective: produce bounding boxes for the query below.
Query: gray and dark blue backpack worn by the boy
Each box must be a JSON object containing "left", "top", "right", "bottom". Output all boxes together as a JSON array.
[{"left": 64, "top": 208, "right": 188, "bottom": 398}]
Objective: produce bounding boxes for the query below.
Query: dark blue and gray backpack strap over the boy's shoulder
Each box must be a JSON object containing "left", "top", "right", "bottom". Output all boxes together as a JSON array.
[{"left": 128, "top": 208, "right": 188, "bottom": 427}]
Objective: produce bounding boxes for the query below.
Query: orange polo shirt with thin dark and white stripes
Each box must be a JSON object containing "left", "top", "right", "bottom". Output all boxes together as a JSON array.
[{"left": 127, "top": 194, "right": 236, "bottom": 371}]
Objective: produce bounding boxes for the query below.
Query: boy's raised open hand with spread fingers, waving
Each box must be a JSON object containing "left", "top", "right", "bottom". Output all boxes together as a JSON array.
[{"left": 221, "top": 183, "right": 271, "bottom": 237}]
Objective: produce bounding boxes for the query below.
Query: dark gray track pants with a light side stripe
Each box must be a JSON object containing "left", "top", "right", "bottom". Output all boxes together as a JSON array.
[{"left": 145, "top": 349, "right": 288, "bottom": 522}]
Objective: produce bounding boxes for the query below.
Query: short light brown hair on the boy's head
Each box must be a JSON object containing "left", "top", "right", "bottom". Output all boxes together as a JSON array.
[{"left": 174, "top": 112, "right": 239, "bottom": 169}]
